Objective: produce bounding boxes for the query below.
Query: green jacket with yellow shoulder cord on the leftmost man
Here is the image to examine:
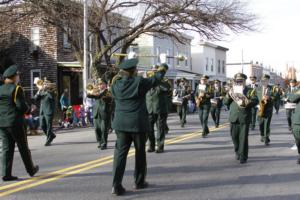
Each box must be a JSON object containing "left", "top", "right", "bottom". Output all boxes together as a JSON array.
[{"left": 0, "top": 84, "right": 29, "bottom": 127}]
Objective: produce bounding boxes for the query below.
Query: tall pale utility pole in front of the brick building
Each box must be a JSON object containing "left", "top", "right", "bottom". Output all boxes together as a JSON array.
[{"left": 82, "top": 0, "right": 88, "bottom": 103}]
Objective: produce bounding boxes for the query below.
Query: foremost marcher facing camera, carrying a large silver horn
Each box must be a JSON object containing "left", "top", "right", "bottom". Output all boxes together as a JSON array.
[{"left": 224, "top": 73, "right": 258, "bottom": 164}]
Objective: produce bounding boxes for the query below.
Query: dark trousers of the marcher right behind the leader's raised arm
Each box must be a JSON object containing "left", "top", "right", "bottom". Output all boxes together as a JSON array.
[{"left": 148, "top": 113, "right": 168, "bottom": 150}]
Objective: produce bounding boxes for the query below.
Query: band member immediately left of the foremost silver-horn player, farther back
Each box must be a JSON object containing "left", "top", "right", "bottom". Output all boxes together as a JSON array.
[{"left": 210, "top": 80, "right": 225, "bottom": 128}]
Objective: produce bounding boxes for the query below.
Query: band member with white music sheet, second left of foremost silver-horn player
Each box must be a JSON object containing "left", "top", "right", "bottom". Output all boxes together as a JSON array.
[{"left": 195, "top": 75, "right": 213, "bottom": 137}]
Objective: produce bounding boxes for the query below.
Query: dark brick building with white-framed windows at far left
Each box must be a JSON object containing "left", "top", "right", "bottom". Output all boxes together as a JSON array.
[{"left": 0, "top": 12, "right": 83, "bottom": 104}]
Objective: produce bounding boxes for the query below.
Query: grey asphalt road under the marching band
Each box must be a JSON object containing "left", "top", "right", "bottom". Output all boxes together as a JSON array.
[{"left": 0, "top": 110, "right": 300, "bottom": 200}]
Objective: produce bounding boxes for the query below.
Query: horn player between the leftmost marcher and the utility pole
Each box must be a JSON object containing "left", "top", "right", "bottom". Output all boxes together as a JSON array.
[{"left": 34, "top": 79, "right": 56, "bottom": 146}]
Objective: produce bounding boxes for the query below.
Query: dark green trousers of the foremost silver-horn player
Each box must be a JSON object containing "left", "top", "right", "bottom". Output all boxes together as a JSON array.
[{"left": 230, "top": 122, "right": 250, "bottom": 160}]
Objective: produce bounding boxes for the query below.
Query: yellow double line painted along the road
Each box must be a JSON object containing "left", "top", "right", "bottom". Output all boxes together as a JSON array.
[{"left": 0, "top": 123, "right": 229, "bottom": 197}]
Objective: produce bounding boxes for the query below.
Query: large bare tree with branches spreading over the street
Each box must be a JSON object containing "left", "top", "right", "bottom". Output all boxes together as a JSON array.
[{"left": 1, "top": 0, "right": 256, "bottom": 78}]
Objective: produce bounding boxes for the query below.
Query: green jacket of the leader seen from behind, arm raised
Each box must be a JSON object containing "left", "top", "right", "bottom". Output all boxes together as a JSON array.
[{"left": 111, "top": 72, "right": 165, "bottom": 133}]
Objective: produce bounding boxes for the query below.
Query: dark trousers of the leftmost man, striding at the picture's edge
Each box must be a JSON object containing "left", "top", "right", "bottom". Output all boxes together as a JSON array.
[{"left": 0, "top": 126, "right": 34, "bottom": 176}]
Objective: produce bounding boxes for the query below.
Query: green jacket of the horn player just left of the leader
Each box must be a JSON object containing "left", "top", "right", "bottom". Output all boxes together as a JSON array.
[{"left": 87, "top": 90, "right": 112, "bottom": 120}]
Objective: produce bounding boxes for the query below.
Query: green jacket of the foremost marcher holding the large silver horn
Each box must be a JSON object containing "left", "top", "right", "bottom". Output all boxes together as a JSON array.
[{"left": 224, "top": 87, "right": 258, "bottom": 124}]
